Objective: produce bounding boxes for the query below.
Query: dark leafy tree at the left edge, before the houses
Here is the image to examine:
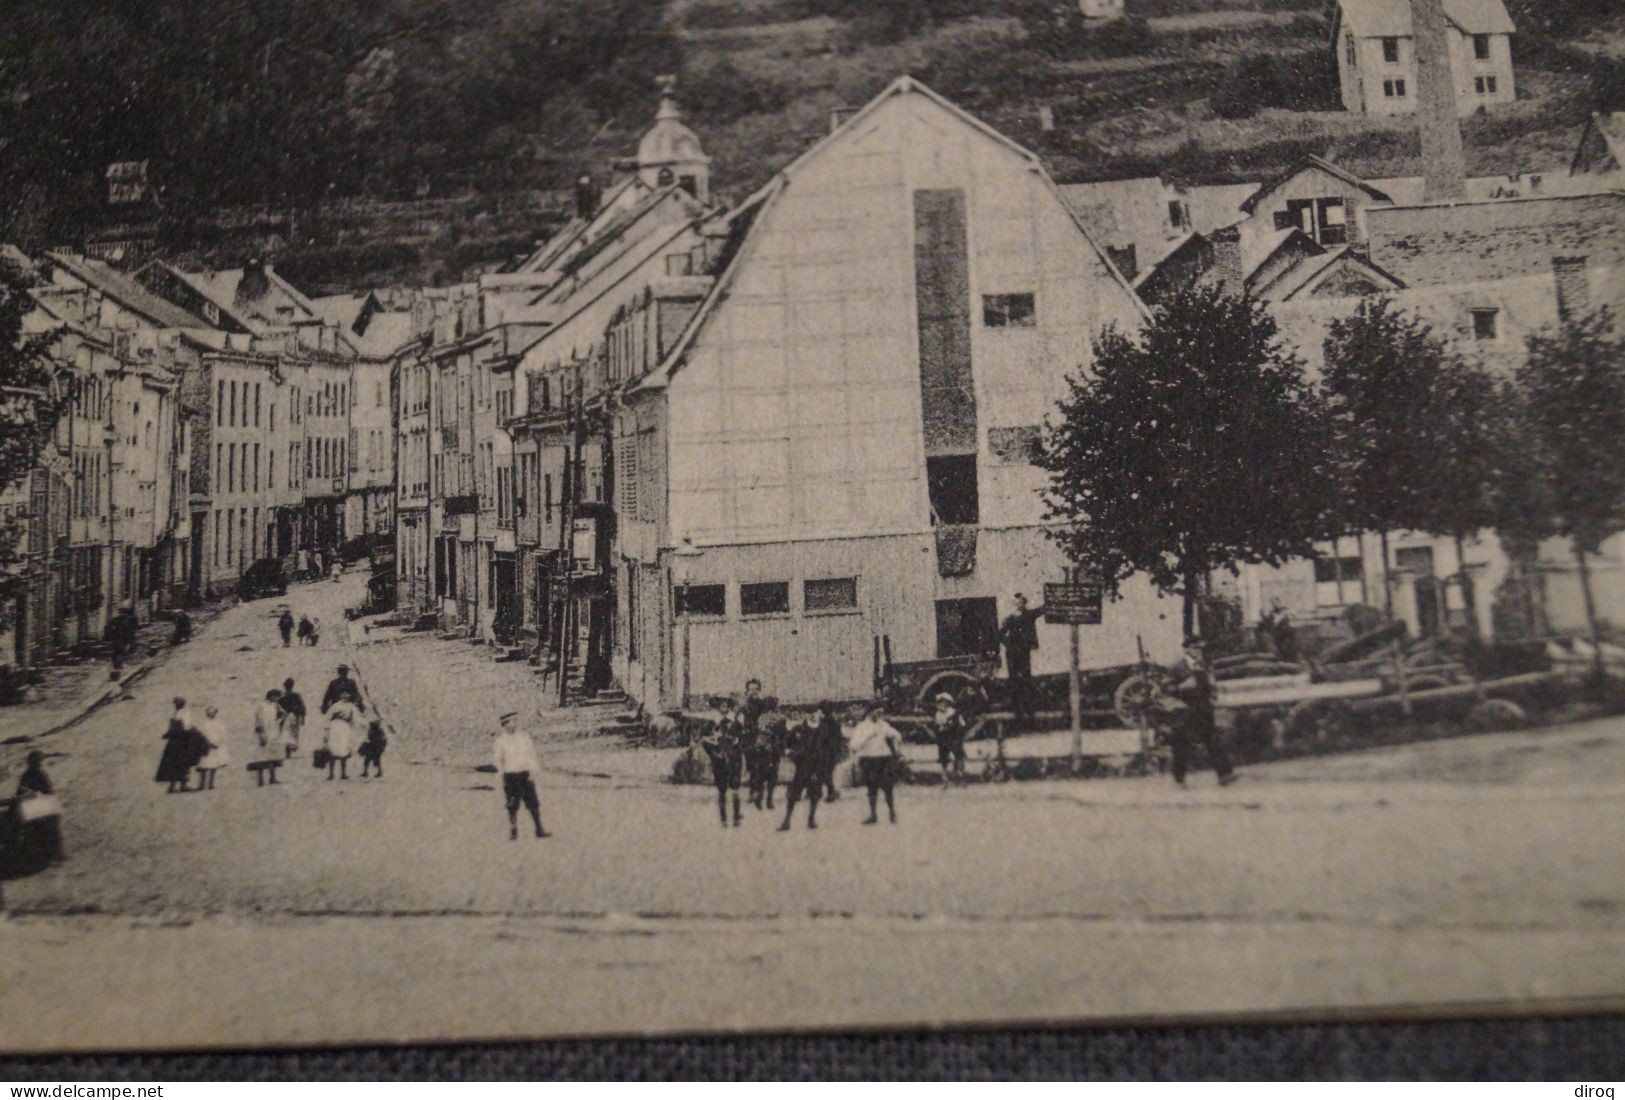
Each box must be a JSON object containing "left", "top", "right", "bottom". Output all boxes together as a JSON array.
[{"left": 0, "top": 260, "right": 63, "bottom": 626}]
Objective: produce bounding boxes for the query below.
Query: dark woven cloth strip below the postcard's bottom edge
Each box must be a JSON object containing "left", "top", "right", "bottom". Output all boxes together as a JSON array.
[{"left": 0, "top": 1016, "right": 1625, "bottom": 1084}]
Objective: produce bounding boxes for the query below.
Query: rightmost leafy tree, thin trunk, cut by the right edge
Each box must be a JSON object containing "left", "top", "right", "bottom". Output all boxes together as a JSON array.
[{"left": 1518, "top": 309, "right": 1625, "bottom": 679}]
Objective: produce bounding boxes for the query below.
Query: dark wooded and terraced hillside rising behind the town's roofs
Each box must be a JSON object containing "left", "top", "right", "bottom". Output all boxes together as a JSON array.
[{"left": 0, "top": 0, "right": 1625, "bottom": 289}]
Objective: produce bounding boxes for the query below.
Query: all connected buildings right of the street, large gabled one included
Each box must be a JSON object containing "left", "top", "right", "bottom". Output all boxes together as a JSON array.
[{"left": 397, "top": 51, "right": 1625, "bottom": 708}]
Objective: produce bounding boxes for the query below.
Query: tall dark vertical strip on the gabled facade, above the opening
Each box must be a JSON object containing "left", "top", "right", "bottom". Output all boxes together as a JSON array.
[{"left": 913, "top": 188, "right": 977, "bottom": 457}]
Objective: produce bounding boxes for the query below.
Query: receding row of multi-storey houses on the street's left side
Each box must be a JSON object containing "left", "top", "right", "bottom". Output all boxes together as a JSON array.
[{"left": 0, "top": 250, "right": 395, "bottom": 668}]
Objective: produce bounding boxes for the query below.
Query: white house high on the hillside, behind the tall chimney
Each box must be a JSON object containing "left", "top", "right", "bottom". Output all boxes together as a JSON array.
[{"left": 1331, "top": 0, "right": 1518, "bottom": 115}]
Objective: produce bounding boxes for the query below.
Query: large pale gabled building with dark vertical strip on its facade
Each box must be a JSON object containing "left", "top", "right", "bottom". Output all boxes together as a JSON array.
[{"left": 614, "top": 78, "right": 1180, "bottom": 705}]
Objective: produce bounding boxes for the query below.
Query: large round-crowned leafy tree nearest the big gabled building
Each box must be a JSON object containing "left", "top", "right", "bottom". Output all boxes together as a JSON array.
[{"left": 1042, "top": 288, "right": 1334, "bottom": 634}]
